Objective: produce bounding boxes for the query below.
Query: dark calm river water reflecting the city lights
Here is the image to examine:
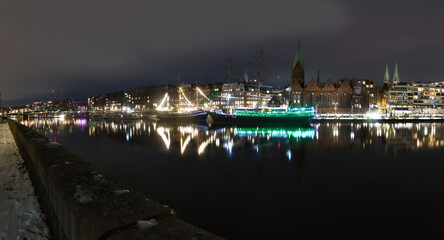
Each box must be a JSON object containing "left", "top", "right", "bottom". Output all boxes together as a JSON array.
[{"left": 22, "top": 119, "right": 444, "bottom": 239}]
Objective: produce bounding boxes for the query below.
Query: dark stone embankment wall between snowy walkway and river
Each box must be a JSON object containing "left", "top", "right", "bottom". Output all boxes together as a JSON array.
[{"left": 8, "top": 120, "right": 220, "bottom": 240}]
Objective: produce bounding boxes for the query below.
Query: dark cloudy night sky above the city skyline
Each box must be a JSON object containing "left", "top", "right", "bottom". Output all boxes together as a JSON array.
[{"left": 0, "top": 0, "right": 444, "bottom": 106}]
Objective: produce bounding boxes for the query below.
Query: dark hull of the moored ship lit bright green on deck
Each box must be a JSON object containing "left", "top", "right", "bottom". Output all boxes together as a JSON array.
[{"left": 207, "top": 108, "right": 315, "bottom": 126}]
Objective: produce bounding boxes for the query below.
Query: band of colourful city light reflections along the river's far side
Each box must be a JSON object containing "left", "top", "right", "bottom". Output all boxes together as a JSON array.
[{"left": 22, "top": 119, "right": 444, "bottom": 156}]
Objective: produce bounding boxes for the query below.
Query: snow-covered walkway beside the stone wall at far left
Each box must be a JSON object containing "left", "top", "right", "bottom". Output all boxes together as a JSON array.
[{"left": 0, "top": 120, "right": 50, "bottom": 240}]
